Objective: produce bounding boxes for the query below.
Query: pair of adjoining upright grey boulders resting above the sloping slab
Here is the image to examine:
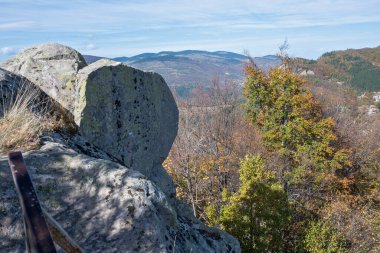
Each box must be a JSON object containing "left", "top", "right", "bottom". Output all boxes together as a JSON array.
[{"left": 2, "top": 44, "right": 178, "bottom": 197}]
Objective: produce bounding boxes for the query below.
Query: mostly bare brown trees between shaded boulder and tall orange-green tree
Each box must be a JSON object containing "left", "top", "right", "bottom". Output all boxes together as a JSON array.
[{"left": 165, "top": 79, "right": 257, "bottom": 220}]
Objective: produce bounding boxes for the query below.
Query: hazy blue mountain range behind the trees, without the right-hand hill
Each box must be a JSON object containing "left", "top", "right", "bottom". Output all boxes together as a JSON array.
[{"left": 84, "top": 50, "right": 280, "bottom": 87}]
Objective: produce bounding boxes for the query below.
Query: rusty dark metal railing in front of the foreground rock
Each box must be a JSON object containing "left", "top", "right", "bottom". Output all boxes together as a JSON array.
[{"left": 8, "top": 151, "right": 84, "bottom": 253}]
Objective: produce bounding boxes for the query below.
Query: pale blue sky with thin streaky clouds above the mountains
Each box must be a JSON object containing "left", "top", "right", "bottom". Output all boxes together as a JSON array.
[{"left": 0, "top": 0, "right": 380, "bottom": 62}]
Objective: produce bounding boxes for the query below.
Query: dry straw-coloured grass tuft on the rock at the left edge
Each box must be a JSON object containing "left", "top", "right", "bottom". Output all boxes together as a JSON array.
[{"left": 0, "top": 82, "right": 53, "bottom": 153}]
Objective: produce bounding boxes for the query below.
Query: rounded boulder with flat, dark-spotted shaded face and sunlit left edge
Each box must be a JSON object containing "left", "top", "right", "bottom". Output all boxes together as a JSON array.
[{"left": 74, "top": 60, "right": 178, "bottom": 190}]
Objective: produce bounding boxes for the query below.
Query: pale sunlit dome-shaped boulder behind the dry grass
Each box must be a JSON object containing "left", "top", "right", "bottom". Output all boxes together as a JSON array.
[{"left": 0, "top": 44, "right": 87, "bottom": 111}]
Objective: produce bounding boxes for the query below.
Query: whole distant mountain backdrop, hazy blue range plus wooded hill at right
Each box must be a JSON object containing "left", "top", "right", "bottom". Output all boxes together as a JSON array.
[{"left": 84, "top": 46, "right": 380, "bottom": 94}]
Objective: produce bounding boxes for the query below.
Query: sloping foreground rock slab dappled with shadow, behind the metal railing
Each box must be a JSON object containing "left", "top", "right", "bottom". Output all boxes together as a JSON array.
[{"left": 0, "top": 134, "right": 240, "bottom": 253}]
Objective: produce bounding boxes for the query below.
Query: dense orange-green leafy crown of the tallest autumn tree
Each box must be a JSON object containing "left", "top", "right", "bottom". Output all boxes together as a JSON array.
[{"left": 244, "top": 66, "right": 350, "bottom": 191}]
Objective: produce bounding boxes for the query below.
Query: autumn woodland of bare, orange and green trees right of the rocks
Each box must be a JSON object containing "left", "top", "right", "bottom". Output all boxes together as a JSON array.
[{"left": 165, "top": 55, "right": 380, "bottom": 253}]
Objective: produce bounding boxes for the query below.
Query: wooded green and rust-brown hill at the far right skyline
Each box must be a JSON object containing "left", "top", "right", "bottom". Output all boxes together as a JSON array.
[{"left": 295, "top": 47, "right": 380, "bottom": 92}]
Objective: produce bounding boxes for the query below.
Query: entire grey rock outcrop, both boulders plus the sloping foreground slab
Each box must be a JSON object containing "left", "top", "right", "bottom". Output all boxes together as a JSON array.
[{"left": 0, "top": 44, "right": 240, "bottom": 252}]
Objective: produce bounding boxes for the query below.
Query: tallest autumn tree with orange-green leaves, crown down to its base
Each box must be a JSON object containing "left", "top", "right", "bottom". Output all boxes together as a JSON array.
[{"left": 244, "top": 66, "right": 352, "bottom": 250}]
